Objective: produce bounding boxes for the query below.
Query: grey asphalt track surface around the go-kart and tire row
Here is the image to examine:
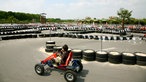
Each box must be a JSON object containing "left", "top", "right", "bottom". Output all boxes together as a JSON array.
[{"left": 0, "top": 37, "right": 146, "bottom": 82}]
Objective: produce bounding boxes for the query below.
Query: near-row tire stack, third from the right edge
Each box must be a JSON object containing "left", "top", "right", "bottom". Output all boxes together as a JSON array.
[{"left": 108, "top": 51, "right": 122, "bottom": 64}]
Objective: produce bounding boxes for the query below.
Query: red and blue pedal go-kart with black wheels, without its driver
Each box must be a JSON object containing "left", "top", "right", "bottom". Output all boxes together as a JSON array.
[{"left": 35, "top": 51, "right": 83, "bottom": 82}]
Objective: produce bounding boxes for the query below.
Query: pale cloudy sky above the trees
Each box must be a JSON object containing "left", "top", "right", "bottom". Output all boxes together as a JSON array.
[{"left": 0, "top": 0, "right": 146, "bottom": 19}]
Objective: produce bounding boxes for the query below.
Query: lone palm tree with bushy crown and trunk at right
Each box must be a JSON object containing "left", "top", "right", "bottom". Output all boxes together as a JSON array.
[{"left": 117, "top": 8, "right": 132, "bottom": 29}]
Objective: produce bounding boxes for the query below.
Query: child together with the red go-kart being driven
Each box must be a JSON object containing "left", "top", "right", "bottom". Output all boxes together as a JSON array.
[{"left": 34, "top": 44, "right": 83, "bottom": 82}]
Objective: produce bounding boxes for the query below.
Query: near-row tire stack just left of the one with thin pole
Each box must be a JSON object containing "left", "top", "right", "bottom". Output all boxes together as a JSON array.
[{"left": 82, "top": 49, "right": 96, "bottom": 61}]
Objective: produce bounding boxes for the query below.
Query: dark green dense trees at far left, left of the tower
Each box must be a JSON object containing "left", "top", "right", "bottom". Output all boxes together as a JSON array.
[{"left": 0, "top": 11, "right": 40, "bottom": 23}]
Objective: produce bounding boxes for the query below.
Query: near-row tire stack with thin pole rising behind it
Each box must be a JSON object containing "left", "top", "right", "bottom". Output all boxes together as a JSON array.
[{"left": 96, "top": 51, "right": 108, "bottom": 62}]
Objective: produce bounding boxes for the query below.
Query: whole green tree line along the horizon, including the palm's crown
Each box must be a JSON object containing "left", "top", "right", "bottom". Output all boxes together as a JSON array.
[{"left": 0, "top": 8, "right": 146, "bottom": 25}]
